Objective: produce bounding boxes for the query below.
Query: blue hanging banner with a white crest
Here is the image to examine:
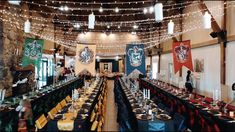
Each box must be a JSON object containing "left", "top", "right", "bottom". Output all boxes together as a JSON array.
[{"left": 126, "top": 44, "right": 146, "bottom": 76}]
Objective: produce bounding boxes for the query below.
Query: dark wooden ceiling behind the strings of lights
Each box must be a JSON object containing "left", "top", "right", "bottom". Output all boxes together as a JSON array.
[{"left": 24, "top": 0, "right": 188, "bottom": 32}]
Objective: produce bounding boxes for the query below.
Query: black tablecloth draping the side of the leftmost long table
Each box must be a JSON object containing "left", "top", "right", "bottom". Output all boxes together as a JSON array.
[{"left": 0, "top": 78, "right": 84, "bottom": 131}]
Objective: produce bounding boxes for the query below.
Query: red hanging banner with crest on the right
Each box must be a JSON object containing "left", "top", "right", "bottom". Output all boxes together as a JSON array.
[{"left": 172, "top": 40, "right": 193, "bottom": 73}]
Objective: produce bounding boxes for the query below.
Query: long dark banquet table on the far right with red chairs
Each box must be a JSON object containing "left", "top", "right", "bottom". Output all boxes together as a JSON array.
[{"left": 140, "top": 79, "right": 235, "bottom": 131}]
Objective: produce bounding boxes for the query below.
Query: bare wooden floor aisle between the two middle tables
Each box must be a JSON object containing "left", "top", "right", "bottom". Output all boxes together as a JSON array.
[{"left": 103, "top": 80, "right": 119, "bottom": 131}]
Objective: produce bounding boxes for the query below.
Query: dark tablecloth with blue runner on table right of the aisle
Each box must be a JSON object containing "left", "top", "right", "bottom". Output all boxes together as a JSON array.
[{"left": 114, "top": 79, "right": 174, "bottom": 131}]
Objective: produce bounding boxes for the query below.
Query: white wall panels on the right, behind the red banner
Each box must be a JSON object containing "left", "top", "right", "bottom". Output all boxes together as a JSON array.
[{"left": 160, "top": 45, "right": 220, "bottom": 97}]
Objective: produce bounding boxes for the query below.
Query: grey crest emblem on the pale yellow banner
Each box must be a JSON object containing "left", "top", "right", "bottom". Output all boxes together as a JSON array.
[{"left": 78, "top": 47, "right": 94, "bottom": 64}]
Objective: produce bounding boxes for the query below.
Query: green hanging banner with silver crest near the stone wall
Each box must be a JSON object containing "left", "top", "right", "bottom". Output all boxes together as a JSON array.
[{"left": 22, "top": 38, "right": 44, "bottom": 67}]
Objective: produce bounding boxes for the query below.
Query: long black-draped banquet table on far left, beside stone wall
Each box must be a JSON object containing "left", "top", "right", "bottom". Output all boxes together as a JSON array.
[{"left": 0, "top": 78, "right": 84, "bottom": 131}]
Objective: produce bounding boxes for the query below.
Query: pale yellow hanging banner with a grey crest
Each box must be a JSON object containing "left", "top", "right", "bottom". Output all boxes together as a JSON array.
[{"left": 75, "top": 45, "right": 96, "bottom": 76}]
